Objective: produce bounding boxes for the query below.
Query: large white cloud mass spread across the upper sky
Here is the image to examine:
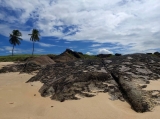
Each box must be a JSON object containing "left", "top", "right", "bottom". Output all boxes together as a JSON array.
[{"left": 0, "top": 0, "right": 160, "bottom": 52}]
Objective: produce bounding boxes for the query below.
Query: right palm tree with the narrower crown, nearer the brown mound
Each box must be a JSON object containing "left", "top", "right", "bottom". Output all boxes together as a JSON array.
[{"left": 28, "top": 29, "right": 40, "bottom": 56}]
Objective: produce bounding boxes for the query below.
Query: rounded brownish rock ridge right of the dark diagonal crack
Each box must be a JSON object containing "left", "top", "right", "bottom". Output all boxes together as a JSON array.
[{"left": 118, "top": 78, "right": 154, "bottom": 112}]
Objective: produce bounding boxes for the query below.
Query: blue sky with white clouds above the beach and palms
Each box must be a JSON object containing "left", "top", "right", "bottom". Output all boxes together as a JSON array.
[{"left": 0, "top": 0, "right": 160, "bottom": 55}]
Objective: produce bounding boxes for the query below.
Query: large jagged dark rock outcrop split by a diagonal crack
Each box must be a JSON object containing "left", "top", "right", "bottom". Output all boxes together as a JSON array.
[{"left": 27, "top": 54, "right": 160, "bottom": 112}]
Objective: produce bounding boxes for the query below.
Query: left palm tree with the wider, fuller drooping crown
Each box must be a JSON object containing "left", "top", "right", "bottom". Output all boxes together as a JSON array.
[{"left": 9, "top": 30, "right": 22, "bottom": 56}]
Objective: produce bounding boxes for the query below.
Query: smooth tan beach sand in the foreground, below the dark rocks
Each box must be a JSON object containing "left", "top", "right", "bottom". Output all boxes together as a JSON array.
[{"left": 0, "top": 63, "right": 160, "bottom": 119}]
